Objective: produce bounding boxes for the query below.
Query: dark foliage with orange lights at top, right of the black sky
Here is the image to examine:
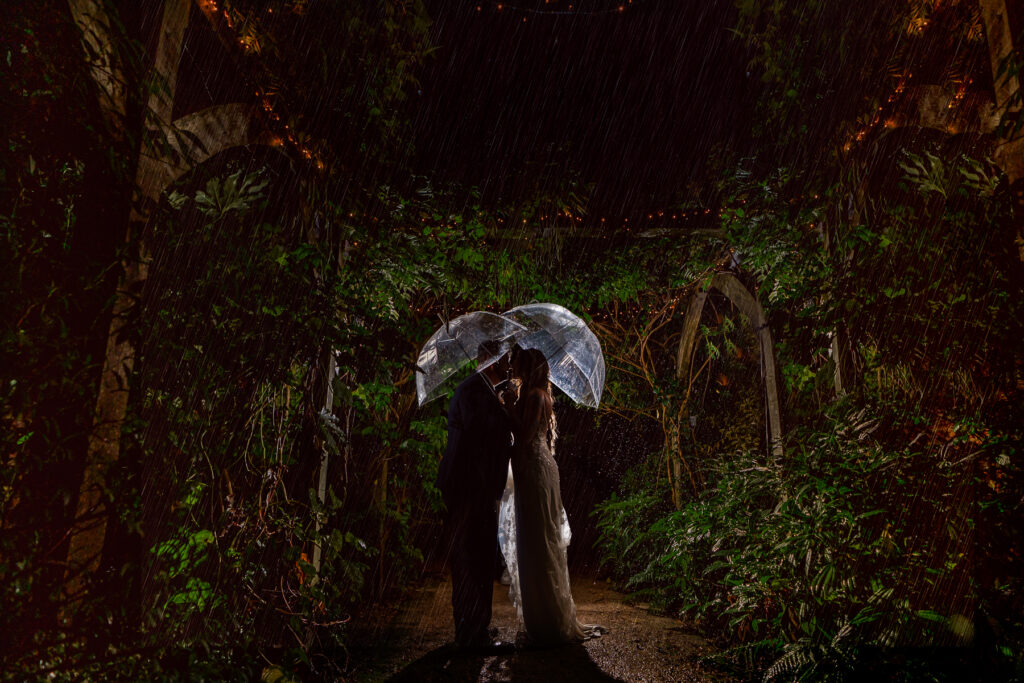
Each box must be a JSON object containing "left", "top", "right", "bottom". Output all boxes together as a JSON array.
[{"left": 732, "top": 0, "right": 987, "bottom": 171}]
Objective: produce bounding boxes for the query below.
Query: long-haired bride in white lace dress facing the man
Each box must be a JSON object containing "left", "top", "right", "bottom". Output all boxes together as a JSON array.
[{"left": 499, "top": 349, "right": 606, "bottom": 645}]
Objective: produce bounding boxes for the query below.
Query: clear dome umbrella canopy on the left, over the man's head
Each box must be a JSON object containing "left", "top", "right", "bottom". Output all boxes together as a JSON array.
[{"left": 416, "top": 310, "right": 526, "bottom": 405}]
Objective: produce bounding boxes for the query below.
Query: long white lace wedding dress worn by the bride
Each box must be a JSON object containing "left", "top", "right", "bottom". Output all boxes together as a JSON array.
[{"left": 498, "top": 416, "right": 605, "bottom": 645}]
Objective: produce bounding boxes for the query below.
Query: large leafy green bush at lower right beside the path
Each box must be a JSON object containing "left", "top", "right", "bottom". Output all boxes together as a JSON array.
[{"left": 598, "top": 412, "right": 1011, "bottom": 680}]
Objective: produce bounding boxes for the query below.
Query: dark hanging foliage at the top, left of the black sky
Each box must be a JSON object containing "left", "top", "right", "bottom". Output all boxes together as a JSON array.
[{"left": 225, "top": 0, "right": 433, "bottom": 179}]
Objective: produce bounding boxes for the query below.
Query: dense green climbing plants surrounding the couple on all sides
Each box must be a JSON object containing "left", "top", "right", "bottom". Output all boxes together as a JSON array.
[{"left": 0, "top": 0, "right": 1024, "bottom": 680}]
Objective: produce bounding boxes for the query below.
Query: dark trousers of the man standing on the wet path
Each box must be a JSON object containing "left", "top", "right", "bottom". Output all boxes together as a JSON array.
[{"left": 446, "top": 501, "right": 498, "bottom": 645}]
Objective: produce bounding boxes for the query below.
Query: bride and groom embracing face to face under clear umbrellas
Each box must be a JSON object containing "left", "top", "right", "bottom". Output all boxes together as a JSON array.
[{"left": 437, "top": 341, "right": 604, "bottom": 650}]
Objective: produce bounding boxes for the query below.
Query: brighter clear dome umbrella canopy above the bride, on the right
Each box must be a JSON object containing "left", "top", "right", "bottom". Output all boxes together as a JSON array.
[{"left": 502, "top": 303, "right": 604, "bottom": 408}]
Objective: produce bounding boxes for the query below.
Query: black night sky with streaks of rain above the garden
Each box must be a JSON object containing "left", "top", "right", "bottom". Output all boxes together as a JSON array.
[{"left": 414, "top": 0, "right": 754, "bottom": 215}]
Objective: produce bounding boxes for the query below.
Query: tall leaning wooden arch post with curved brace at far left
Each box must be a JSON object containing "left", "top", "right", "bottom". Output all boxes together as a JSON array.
[{"left": 65, "top": 0, "right": 272, "bottom": 599}]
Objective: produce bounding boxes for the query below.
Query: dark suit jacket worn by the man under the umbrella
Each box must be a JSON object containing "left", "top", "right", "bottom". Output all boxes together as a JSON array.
[{"left": 437, "top": 373, "right": 512, "bottom": 510}]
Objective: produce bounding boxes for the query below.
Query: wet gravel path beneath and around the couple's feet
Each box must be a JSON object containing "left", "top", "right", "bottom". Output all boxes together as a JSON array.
[{"left": 349, "top": 578, "right": 729, "bottom": 683}]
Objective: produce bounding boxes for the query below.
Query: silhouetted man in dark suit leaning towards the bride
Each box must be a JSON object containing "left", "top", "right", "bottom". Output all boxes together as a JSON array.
[{"left": 437, "top": 340, "right": 514, "bottom": 649}]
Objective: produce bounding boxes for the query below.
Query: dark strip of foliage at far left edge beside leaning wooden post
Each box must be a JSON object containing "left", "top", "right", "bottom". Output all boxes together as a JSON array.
[{"left": 0, "top": 2, "right": 149, "bottom": 680}]
